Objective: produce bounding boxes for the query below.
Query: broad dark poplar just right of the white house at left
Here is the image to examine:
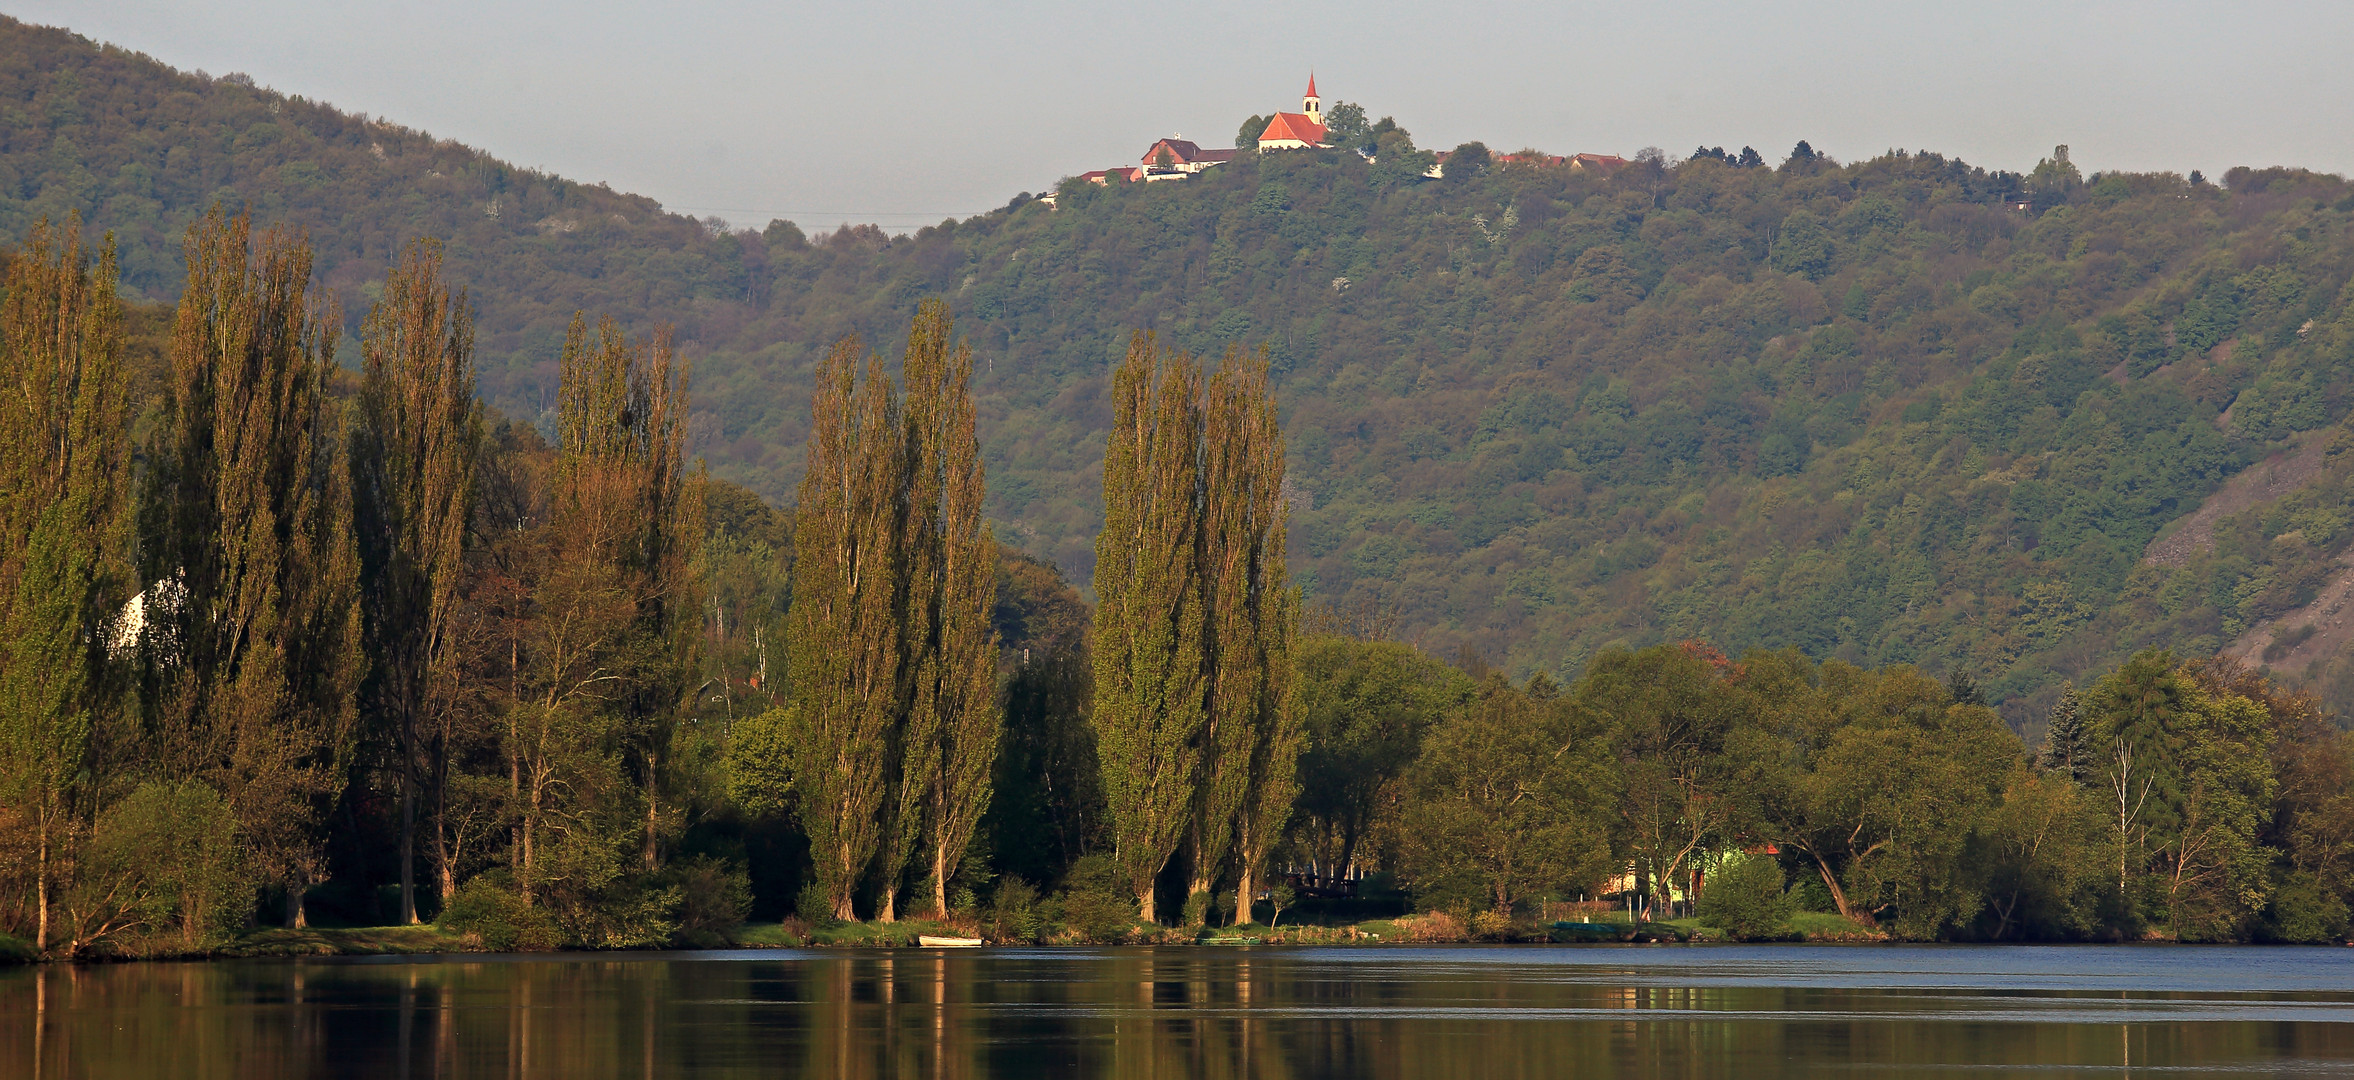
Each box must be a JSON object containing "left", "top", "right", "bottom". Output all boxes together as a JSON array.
[{"left": 141, "top": 207, "right": 365, "bottom": 925}]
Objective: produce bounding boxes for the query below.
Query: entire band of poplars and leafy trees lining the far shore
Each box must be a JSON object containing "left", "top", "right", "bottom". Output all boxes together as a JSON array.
[{"left": 0, "top": 212, "right": 2354, "bottom": 958}]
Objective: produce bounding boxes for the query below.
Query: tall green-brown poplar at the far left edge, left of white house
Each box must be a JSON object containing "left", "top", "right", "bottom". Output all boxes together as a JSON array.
[{"left": 0, "top": 221, "right": 129, "bottom": 953}]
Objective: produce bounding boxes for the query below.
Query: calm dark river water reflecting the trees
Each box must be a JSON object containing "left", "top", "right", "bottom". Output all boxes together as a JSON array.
[{"left": 0, "top": 946, "right": 2354, "bottom": 1080}]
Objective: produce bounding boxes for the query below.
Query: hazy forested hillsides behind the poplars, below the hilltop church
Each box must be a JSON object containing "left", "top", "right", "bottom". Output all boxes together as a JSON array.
[{"left": 13, "top": 21, "right": 2354, "bottom": 722}]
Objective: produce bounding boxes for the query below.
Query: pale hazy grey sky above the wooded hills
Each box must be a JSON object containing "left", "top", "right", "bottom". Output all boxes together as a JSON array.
[{"left": 7, "top": 0, "right": 2354, "bottom": 228}]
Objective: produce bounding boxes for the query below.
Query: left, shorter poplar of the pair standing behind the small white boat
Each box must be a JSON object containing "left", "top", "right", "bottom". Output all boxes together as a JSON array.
[{"left": 786, "top": 339, "right": 904, "bottom": 920}]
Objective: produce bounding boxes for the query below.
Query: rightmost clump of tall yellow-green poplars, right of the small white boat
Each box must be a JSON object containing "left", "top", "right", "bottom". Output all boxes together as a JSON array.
[{"left": 1092, "top": 334, "right": 1302, "bottom": 922}]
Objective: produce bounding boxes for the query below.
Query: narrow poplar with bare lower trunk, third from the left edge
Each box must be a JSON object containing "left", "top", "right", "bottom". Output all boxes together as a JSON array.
[{"left": 353, "top": 240, "right": 483, "bottom": 922}]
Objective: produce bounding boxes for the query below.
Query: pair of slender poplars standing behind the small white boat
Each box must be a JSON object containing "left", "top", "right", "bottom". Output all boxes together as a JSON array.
[{"left": 784, "top": 301, "right": 1003, "bottom": 920}]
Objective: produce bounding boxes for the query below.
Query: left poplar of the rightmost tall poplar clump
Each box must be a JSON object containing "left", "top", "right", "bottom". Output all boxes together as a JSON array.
[{"left": 1090, "top": 332, "right": 1203, "bottom": 920}]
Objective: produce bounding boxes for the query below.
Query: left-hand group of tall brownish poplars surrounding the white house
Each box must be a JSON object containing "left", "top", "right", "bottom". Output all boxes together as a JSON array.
[{"left": 0, "top": 207, "right": 701, "bottom": 953}]
